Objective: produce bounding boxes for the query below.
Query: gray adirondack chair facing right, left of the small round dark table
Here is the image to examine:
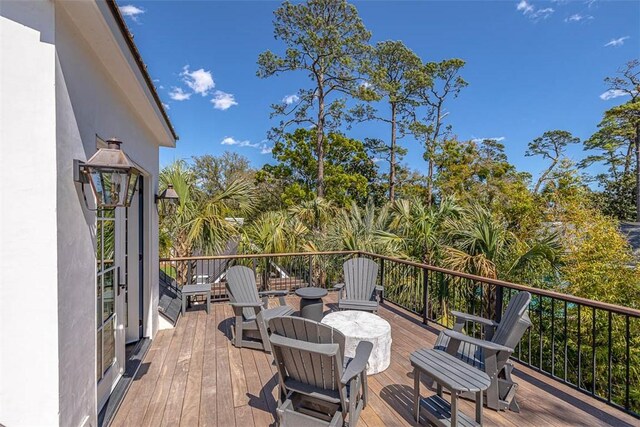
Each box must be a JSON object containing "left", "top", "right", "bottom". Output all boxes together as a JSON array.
[{"left": 226, "top": 265, "right": 295, "bottom": 352}]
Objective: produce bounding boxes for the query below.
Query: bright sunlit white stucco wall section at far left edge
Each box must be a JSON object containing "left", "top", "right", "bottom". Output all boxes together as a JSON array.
[{"left": 0, "top": 0, "right": 59, "bottom": 426}]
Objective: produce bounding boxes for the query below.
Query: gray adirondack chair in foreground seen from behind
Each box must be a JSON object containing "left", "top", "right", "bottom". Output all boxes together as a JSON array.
[{"left": 269, "top": 317, "right": 373, "bottom": 427}]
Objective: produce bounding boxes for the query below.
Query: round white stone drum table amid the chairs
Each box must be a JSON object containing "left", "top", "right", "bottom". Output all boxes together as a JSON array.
[{"left": 322, "top": 310, "right": 391, "bottom": 375}]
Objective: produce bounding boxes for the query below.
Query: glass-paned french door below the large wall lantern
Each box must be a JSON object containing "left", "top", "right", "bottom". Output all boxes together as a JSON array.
[{"left": 96, "top": 208, "right": 127, "bottom": 411}]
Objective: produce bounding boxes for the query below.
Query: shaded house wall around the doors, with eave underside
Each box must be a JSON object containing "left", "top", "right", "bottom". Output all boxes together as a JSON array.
[{"left": 56, "top": 8, "right": 158, "bottom": 426}]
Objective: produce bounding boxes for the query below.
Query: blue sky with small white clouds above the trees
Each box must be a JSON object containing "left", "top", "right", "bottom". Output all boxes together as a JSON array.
[{"left": 119, "top": 0, "right": 640, "bottom": 183}]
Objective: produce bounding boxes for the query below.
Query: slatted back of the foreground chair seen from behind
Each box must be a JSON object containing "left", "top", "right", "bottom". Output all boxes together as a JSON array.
[{"left": 269, "top": 317, "right": 345, "bottom": 395}]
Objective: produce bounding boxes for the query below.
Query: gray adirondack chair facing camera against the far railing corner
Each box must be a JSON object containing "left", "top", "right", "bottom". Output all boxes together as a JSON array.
[{"left": 335, "top": 258, "right": 382, "bottom": 313}]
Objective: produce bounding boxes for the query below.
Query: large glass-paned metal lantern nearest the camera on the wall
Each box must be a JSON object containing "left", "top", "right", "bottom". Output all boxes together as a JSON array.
[{"left": 74, "top": 139, "right": 140, "bottom": 208}]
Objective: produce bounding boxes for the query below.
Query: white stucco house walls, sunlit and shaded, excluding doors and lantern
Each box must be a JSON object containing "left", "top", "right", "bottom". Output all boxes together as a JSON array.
[{"left": 0, "top": 0, "right": 166, "bottom": 426}]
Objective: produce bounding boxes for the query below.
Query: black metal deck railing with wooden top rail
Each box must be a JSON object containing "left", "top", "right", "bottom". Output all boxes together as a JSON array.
[{"left": 160, "top": 251, "right": 640, "bottom": 418}]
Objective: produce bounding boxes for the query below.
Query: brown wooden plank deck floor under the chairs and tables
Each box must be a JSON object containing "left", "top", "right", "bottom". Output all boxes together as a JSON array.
[{"left": 112, "top": 294, "right": 639, "bottom": 427}]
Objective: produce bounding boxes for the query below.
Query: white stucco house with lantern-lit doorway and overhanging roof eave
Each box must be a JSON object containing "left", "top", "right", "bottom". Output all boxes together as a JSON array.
[{"left": 0, "top": 0, "right": 177, "bottom": 427}]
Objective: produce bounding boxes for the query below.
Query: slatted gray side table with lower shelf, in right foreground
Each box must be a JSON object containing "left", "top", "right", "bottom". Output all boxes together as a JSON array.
[{"left": 409, "top": 349, "right": 491, "bottom": 426}]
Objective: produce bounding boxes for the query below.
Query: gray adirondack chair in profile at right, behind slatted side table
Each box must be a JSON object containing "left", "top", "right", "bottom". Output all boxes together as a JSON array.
[{"left": 435, "top": 291, "right": 531, "bottom": 412}]
